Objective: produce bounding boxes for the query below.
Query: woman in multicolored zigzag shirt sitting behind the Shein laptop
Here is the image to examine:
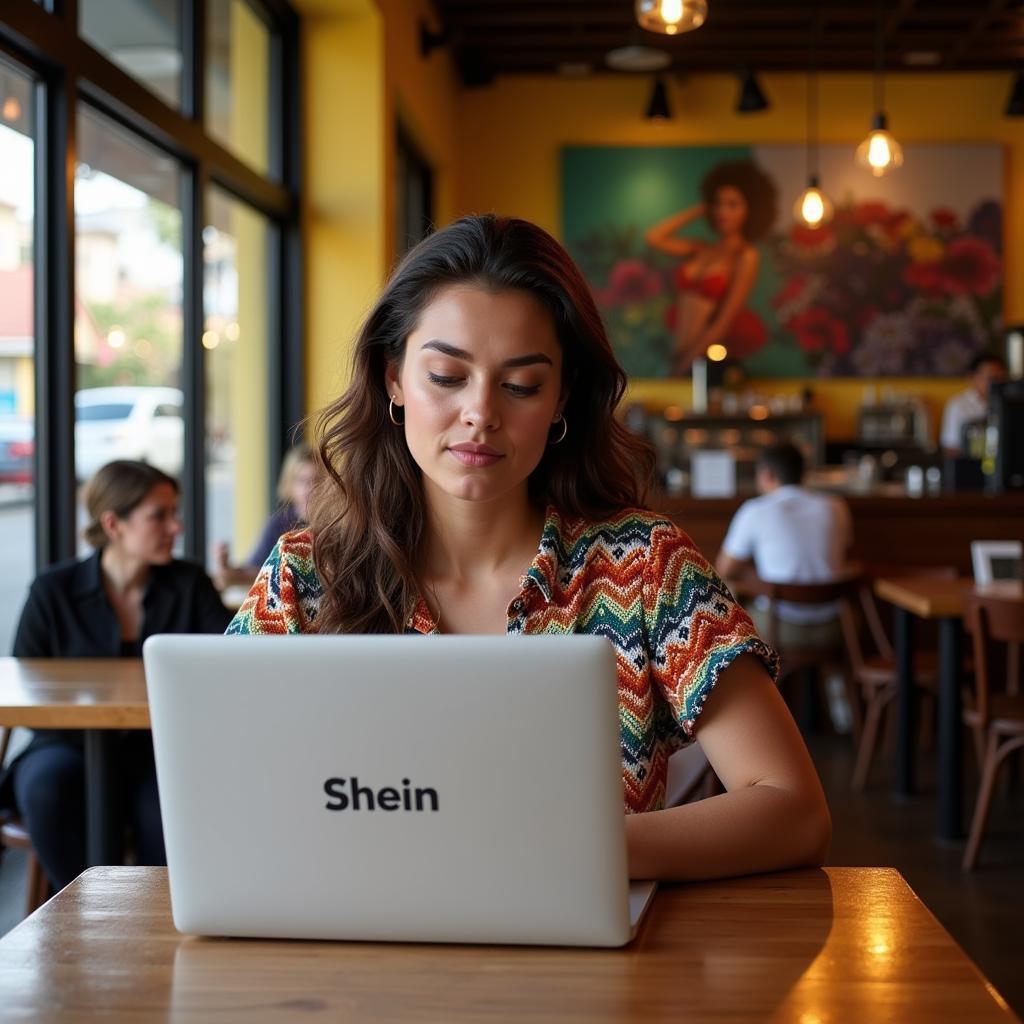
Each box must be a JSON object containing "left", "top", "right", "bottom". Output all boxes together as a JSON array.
[{"left": 228, "top": 216, "right": 830, "bottom": 879}]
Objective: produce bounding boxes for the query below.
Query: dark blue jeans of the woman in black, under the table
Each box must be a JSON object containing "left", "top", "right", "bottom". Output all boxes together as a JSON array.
[{"left": 13, "top": 732, "right": 167, "bottom": 889}]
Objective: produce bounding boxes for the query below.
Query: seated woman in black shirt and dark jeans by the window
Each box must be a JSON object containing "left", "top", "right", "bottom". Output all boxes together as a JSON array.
[{"left": 0, "top": 461, "right": 230, "bottom": 889}]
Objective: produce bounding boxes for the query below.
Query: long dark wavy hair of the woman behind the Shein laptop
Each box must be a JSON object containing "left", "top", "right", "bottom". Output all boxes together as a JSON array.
[{"left": 309, "top": 215, "right": 654, "bottom": 633}]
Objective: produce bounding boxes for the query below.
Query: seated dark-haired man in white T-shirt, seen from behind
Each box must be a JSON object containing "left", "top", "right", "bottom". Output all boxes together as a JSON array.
[{"left": 715, "top": 442, "right": 853, "bottom": 647}]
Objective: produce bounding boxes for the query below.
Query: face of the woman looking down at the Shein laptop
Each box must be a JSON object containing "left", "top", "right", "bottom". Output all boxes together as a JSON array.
[{"left": 385, "top": 285, "right": 565, "bottom": 502}]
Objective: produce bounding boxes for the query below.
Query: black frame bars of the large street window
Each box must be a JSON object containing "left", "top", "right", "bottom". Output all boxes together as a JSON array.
[{"left": 0, "top": 0, "right": 304, "bottom": 571}]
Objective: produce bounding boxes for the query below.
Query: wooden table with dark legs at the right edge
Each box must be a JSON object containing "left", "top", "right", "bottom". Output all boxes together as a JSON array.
[{"left": 874, "top": 577, "right": 1024, "bottom": 840}]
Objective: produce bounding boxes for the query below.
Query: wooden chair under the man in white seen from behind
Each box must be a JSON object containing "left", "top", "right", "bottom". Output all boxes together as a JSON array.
[{"left": 730, "top": 565, "right": 862, "bottom": 742}]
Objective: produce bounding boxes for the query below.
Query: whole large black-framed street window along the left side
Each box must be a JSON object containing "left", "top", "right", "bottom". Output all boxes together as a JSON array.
[{"left": 0, "top": 0, "right": 303, "bottom": 577}]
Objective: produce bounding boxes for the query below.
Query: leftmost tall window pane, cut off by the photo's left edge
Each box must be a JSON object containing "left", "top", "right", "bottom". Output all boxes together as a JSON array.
[{"left": 0, "top": 59, "right": 36, "bottom": 648}]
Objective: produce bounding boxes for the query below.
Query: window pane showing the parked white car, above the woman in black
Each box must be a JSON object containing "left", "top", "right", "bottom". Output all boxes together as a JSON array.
[{"left": 75, "top": 106, "right": 184, "bottom": 520}]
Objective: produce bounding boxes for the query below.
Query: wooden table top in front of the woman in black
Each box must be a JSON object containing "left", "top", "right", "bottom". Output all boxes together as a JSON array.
[{"left": 0, "top": 657, "right": 150, "bottom": 729}]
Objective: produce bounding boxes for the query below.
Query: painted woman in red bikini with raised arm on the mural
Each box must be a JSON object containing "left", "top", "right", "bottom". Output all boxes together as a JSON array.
[{"left": 646, "top": 161, "right": 776, "bottom": 376}]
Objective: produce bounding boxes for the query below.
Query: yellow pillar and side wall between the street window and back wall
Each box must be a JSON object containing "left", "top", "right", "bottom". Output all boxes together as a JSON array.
[{"left": 298, "top": 0, "right": 456, "bottom": 412}]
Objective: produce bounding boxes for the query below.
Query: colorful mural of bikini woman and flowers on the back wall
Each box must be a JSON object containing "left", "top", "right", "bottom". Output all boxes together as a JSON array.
[{"left": 562, "top": 145, "right": 1002, "bottom": 377}]
